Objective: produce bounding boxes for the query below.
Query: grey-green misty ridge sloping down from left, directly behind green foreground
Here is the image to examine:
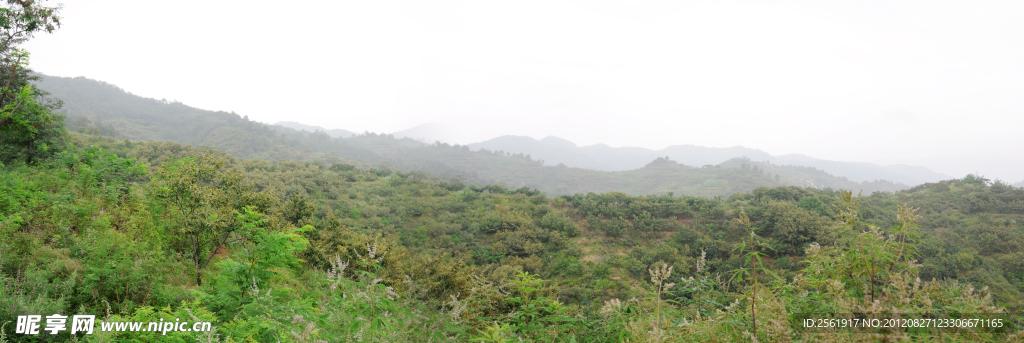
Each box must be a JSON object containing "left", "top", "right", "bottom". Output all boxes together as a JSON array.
[{"left": 37, "top": 76, "right": 907, "bottom": 197}]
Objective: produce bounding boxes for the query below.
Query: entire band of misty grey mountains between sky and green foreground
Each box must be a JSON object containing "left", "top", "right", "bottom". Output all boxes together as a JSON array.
[{"left": 37, "top": 76, "right": 970, "bottom": 197}]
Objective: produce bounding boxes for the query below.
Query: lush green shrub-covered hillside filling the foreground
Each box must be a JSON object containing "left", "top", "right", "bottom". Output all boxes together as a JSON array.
[{"left": 0, "top": 134, "right": 1024, "bottom": 342}]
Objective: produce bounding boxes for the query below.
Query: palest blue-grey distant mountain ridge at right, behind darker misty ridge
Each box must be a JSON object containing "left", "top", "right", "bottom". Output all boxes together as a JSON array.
[{"left": 469, "top": 135, "right": 952, "bottom": 185}]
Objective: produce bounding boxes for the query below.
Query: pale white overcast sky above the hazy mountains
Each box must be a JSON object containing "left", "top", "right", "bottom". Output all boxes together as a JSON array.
[{"left": 27, "top": 0, "right": 1024, "bottom": 182}]
